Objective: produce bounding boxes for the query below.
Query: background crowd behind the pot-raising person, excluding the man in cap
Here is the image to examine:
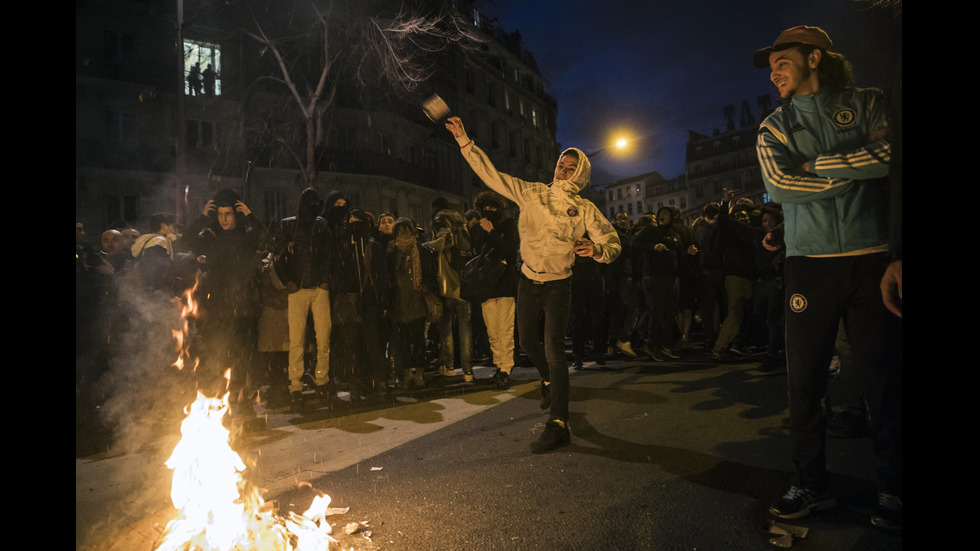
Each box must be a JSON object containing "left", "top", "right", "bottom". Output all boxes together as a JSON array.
[{"left": 76, "top": 188, "right": 782, "bottom": 422}]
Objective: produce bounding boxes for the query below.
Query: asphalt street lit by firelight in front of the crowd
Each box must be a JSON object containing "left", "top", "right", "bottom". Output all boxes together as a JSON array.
[{"left": 75, "top": 351, "right": 902, "bottom": 551}]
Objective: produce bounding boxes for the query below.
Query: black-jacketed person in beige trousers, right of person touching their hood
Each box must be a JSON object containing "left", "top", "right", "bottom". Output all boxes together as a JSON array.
[{"left": 273, "top": 188, "right": 333, "bottom": 408}]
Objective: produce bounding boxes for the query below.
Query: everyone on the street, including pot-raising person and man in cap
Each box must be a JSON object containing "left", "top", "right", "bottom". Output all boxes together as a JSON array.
[{"left": 76, "top": 22, "right": 901, "bottom": 527}]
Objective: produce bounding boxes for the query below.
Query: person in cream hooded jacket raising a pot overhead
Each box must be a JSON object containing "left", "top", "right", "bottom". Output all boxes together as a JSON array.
[{"left": 446, "top": 117, "right": 622, "bottom": 453}]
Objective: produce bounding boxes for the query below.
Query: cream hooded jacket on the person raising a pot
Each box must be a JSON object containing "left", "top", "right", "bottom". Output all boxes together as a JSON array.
[{"left": 456, "top": 134, "right": 622, "bottom": 282}]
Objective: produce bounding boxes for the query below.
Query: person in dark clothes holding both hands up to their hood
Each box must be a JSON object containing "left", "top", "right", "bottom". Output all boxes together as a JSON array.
[{"left": 185, "top": 189, "right": 269, "bottom": 415}]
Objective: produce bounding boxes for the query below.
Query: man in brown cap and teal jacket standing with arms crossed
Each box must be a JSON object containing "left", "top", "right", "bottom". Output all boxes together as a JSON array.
[{"left": 753, "top": 26, "right": 902, "bottom": 528}]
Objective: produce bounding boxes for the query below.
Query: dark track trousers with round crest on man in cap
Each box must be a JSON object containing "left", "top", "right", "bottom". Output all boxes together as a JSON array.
[{"left": 786, "top": 254, "right": 902, "bottom": 495}]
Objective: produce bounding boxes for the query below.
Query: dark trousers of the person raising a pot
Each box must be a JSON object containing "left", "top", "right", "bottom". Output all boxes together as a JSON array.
[{"left": 517, "top": 276, "right": 572, "bottom": 421}]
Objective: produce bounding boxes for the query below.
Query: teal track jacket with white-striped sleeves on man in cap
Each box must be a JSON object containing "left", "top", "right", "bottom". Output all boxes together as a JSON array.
[{"left": 756, "top": 88, "right": 891, "bottom": 256}]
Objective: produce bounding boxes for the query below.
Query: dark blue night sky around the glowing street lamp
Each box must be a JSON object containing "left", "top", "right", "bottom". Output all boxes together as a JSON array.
[{"left": 479, "top": 0, "right": 901, "bottom": 185}]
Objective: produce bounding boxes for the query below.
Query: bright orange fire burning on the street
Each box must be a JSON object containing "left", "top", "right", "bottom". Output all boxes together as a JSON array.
[{"left": 156, "top": 283, "right": 346, "bottom": 551}]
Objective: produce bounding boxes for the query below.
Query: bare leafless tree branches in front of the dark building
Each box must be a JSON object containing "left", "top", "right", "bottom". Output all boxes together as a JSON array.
[{"left": 242, "top": 0, "right": 479, "bottom": 184}]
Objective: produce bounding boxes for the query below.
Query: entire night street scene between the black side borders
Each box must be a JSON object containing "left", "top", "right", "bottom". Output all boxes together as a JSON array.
[{"left": 75, "top": 0, "right": 904, "bottom": 551}]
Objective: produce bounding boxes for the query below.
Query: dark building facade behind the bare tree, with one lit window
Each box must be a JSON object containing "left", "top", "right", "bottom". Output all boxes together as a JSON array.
[{"left": 75, "top": 0, "right": 557, "bottom": 235}]
